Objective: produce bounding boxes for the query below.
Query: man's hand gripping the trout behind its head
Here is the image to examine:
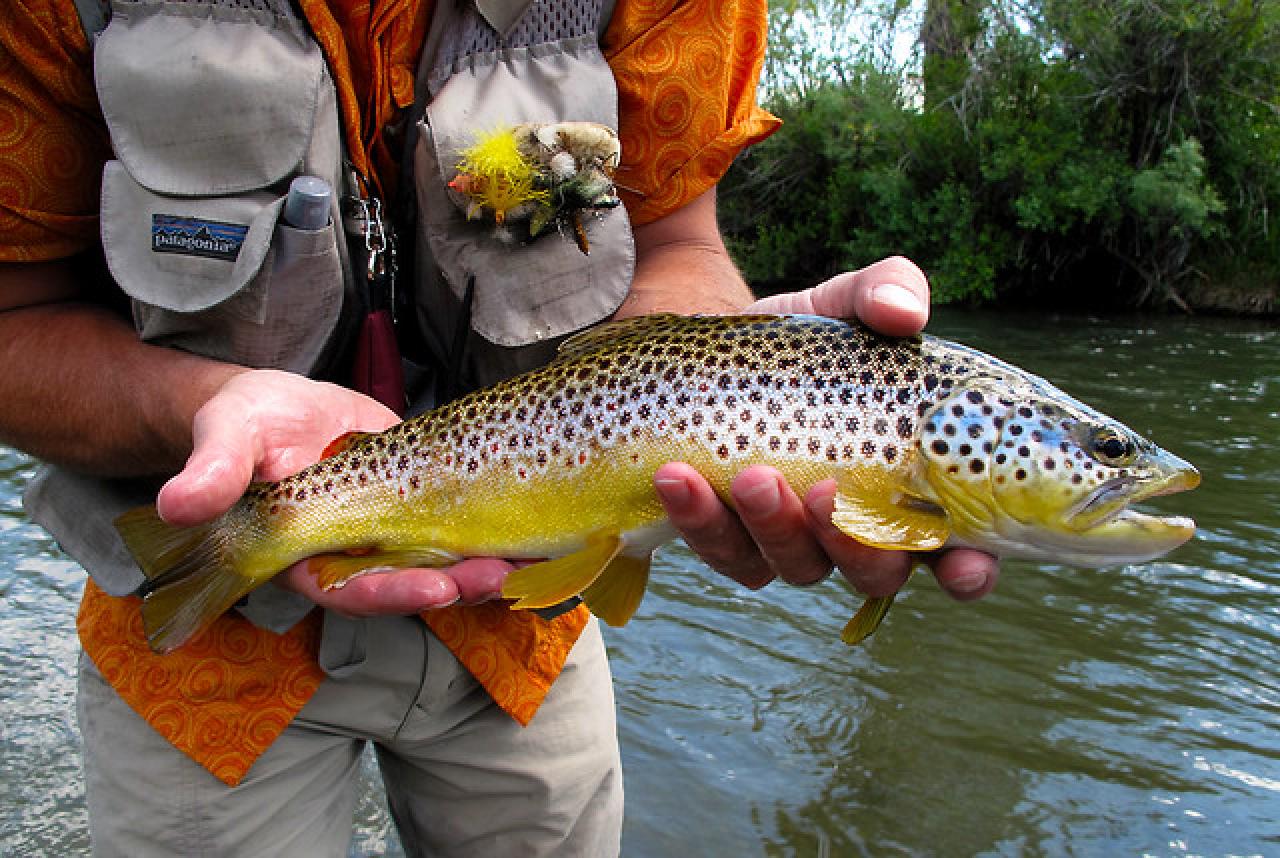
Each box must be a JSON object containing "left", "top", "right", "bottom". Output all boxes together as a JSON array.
[{"left": 654, "top": 257, "right": 1000, "bottom": 609}]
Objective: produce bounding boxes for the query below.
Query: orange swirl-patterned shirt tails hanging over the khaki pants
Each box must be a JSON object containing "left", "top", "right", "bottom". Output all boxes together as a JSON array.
[{"left": 77, "top": 581, "right": 590, "bottom": 786}]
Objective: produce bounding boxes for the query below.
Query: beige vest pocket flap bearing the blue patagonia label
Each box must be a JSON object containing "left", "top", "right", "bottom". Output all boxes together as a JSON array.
[{"left": 102, "top": 161, "right": 284, "bottom": 312}]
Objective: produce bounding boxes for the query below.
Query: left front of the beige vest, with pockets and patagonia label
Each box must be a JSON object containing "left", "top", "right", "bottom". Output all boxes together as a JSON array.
[{"left": 95, "top": 0, "right": 349, "bottom": 373}]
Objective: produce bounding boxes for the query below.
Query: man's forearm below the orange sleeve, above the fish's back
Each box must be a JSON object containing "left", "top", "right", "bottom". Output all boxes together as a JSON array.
[{"left": 617, "top": 191, "right": 753, "bottom": 318}]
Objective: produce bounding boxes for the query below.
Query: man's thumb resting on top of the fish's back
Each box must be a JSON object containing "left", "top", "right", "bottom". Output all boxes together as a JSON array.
[{"left": 748, "top": 256, "right": 929, "bottom": 337}]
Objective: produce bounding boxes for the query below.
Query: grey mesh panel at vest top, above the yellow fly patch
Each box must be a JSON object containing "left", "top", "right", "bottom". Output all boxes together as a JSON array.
[{"left": 435, "top": 0, "right": 604, "bottom": 69}]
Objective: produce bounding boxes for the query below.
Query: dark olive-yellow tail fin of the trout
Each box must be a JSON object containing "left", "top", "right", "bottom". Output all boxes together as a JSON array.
[{"left": 115, "top": 507, "right": 259, "bottom": 653}]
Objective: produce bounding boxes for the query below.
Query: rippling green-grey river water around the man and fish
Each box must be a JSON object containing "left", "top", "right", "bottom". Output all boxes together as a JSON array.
[{"left": 0, "top": 312, "right": 1280, "bottom": 858}]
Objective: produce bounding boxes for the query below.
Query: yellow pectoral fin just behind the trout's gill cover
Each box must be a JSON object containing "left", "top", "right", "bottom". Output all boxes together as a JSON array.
[{"left": 831, "top": 467, "right": 951, "bottom": 551}]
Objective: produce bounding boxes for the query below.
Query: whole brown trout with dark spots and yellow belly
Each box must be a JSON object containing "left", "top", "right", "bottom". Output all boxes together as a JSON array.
[{"left": 116, "top": 315, "right": 1199, "bottom": 652}]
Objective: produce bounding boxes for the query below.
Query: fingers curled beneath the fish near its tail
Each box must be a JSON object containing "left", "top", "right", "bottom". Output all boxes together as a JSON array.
[{"left": 275, "top": 557, "right": 512, "bottom": 617}]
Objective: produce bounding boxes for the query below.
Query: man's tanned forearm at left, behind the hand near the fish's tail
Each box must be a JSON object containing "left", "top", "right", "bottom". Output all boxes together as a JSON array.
[{"left": 0, "top": 264, "right": 243, "bottom": 476}]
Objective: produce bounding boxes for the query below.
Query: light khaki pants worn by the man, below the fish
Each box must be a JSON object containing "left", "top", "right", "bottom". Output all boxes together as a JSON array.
[{"left": 79, "top": 617, "right": 622, "bottom": 858}]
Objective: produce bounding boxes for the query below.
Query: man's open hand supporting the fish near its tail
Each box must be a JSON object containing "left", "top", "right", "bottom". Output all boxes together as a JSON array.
[{"left": 156, "top": 370, "right": 512, "bottom": 616}]
